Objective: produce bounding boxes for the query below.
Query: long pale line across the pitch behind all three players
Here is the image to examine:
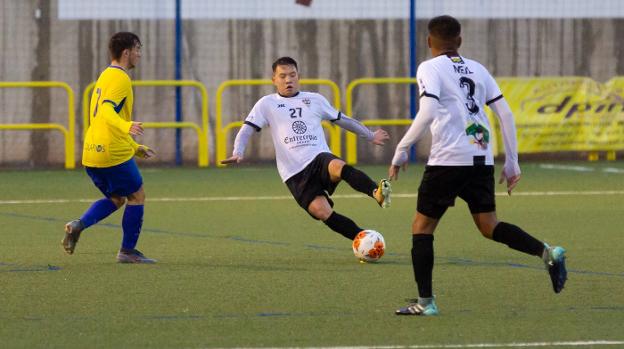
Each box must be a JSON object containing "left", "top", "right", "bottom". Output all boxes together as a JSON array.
[{"left": 0, "top": 190, "right": 624, "bottom": 205}]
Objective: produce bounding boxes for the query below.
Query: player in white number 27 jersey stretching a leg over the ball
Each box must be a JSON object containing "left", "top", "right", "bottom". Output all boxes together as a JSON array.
[{"left": 222, "top": 57, "right": 391, "bottom": 240}]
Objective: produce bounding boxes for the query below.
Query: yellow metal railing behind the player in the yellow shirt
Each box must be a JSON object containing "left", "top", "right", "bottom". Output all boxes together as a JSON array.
[{"left": 82, "top": 80, "right": 209, "bottom": 167}]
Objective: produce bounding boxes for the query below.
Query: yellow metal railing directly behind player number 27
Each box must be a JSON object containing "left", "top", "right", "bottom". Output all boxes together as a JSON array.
[{"left": 215, "top": 79, "right": 340, "bottom": 167}]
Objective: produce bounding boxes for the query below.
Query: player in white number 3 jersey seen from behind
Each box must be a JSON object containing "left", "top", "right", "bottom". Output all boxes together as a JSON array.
[{"left": 388, "top": 16, "right": 567, "bottom": 316}]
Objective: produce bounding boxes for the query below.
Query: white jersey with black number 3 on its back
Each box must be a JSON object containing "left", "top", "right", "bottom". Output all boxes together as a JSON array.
[{"left": 417, "top": 55, "right": 502, "bottom": 166}]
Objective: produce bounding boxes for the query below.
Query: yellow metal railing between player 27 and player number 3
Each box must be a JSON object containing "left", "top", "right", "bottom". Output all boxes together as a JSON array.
[{"left": 345, "top": 78, "right": 418, "bottom": 165}]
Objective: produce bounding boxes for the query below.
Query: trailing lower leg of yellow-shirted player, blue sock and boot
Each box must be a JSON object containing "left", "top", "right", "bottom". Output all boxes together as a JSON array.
[{"left": 61, "top": 198, "right": 117, "bottom": 254}]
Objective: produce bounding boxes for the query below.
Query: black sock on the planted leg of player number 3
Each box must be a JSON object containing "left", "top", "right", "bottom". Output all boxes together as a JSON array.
[{"left": 412, "top": 234, "right": 433, "bottom": 298}]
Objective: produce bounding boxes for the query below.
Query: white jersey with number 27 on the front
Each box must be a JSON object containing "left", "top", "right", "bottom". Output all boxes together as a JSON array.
[{"left": 245, "top": 92, "right": 341, "bottom": 182}]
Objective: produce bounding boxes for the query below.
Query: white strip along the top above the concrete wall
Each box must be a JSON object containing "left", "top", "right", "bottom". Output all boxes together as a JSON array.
[{"left": 58, "top": 0, "right": 624, "bottom": 19}]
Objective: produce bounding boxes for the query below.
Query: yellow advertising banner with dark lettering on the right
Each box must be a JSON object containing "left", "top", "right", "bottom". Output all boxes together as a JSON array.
[{"left": 497, "top": 77, "right": 624, "bottom": 153}]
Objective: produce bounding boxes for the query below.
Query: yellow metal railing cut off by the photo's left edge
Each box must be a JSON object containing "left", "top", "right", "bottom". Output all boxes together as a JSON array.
[{"left": 0, "top": 81, "right": 76, "bottom": 169}]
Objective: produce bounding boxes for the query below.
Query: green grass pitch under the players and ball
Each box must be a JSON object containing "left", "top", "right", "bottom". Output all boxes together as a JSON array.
[{"left": 0, "top": 162, "right": 624, "bottom": 348}]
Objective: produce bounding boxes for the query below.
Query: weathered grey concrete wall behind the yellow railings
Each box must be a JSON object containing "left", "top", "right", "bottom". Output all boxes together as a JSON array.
[{"left": 0, "top": 0, "right": 624, "bottom": 167}]
